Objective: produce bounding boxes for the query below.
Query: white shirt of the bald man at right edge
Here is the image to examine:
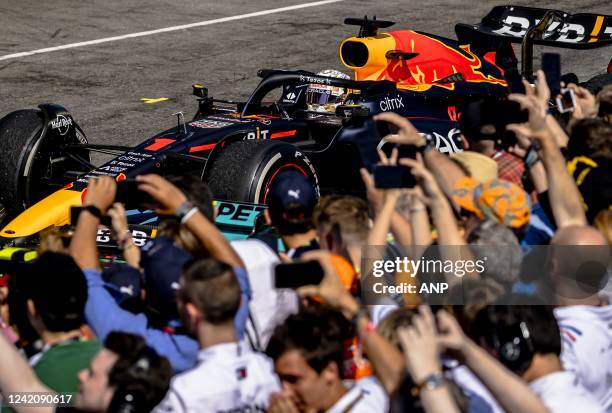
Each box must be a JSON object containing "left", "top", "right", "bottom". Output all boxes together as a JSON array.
[{"left": 555, "top": 305, "right": 612, "bottom": 411}]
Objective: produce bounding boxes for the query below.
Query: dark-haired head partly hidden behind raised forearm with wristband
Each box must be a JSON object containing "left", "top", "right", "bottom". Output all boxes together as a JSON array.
[{"left": 158, "top": 175, "right": 215, "bottom": 258}]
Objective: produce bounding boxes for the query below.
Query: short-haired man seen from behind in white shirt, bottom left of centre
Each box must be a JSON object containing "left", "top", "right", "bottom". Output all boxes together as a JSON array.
[{"left": 155, "top": 259, "right": 280, "bottom": 413}]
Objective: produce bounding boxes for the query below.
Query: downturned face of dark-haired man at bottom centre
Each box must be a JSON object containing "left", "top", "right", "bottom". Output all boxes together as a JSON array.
[{"left": 275, "top": 350, "right": 340, "bottom": 412}]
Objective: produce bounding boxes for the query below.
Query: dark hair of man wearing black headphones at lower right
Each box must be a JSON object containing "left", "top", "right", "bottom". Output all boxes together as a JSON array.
[{"left": 471, "top": 294, "right": 561, "bottom": 374}]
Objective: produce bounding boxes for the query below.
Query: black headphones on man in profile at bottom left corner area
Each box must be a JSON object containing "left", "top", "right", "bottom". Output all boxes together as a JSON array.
[{"left": 107, "top": 347, "right": 153, "bottom": 413}]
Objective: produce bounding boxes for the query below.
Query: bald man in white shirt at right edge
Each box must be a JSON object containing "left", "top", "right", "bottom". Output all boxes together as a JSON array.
[{"left": 539, "top": 226, "right": 612, "bottom": 411}]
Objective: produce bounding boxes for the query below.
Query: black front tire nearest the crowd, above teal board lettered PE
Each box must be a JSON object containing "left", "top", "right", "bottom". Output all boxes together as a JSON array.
[{"left": 204, "top": 140, "right": 319, "bottom": 204}]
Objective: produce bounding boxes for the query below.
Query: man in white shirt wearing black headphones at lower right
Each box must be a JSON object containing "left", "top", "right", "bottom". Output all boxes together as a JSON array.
[{"left": 472, "top": 294, "right": 604, "bottom": 413}]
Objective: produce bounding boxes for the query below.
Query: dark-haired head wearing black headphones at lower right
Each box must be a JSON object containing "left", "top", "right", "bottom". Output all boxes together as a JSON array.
[{"left": 471, "top": 294, "right": 561, "bottom": 380}]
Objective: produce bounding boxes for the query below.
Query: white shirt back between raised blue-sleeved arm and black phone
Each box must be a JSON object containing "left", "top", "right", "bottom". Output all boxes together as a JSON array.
[{"left": 231, "top": 239, "right": 299, "bottom": 350}]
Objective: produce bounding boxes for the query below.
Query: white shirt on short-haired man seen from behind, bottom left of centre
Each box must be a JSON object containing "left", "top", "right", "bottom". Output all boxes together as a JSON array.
[{"left": 153, "top": 343, "right": 280, "bottom": 413}]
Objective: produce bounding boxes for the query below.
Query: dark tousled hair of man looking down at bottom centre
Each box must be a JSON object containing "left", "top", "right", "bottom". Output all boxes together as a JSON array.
[{"left": 266, "top": 305, "right": 352, "bottom": 374}]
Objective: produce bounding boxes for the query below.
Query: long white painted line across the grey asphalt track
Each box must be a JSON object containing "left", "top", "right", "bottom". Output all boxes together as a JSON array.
[{"left": 0, "top": 0, "right": 344, "bottom": 60}]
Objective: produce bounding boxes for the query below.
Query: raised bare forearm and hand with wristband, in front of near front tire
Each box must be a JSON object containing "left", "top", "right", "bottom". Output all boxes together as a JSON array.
[{"left": 136, "top": 175, "right": 244, "bottom": 268}]
